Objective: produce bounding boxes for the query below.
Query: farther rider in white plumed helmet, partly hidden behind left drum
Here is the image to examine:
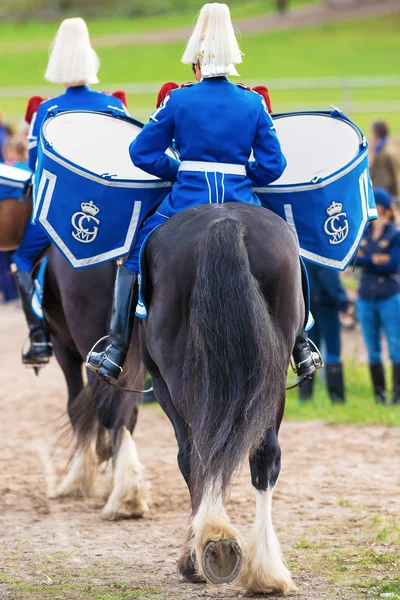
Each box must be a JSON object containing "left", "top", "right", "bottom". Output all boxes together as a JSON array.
[{"left": 12, "top": 18, "right": 126, "bottom": 366}]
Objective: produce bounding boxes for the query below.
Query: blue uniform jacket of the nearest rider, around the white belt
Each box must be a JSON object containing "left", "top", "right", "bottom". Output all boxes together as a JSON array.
[{"left": 130, "top": 77, "right": 286, "bottom": 217}]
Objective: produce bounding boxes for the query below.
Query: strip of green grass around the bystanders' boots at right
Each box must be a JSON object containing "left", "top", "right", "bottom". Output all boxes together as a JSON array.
[{"left": 285, "top": 361, "right": 400, "bottom": 427}]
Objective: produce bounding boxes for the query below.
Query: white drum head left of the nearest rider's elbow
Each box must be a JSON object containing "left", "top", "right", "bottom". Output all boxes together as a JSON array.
[{"left": 43, "top": 111, "right": 173, "bottom": 181}]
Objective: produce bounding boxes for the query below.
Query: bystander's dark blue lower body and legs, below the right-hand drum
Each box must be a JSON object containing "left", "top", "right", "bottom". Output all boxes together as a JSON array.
[{"left": 300, "top": 262, "right": 349, "bottom": 402}]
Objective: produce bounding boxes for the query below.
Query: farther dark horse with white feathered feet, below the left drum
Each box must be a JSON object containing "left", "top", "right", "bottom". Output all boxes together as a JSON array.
[{"left": 43, "top": 246, "right": 148, "bottom": 519}]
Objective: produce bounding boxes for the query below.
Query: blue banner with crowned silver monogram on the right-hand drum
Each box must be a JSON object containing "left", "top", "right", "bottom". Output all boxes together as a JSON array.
[{"left": 254, "top": 113, "right": 377, "bottom": 270}]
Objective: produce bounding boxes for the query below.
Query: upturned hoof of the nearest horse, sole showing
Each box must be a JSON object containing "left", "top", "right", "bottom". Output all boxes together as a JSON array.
[{"left": 202, "top": 540, "right": 243, "bottom": 585}]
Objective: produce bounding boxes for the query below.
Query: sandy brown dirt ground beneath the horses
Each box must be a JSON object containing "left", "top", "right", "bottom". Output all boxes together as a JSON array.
[{"left": 0, "top": 306, "right": 400, "bottom": 600}]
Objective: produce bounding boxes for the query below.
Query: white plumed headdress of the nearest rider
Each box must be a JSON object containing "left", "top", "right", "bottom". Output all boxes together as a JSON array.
[{"left": 182, "top": 3, "right": 242, "bottom": 77}]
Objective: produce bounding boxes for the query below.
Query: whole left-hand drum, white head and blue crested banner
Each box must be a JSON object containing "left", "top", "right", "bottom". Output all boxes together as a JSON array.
[{"left": 34, "top": 111, "right": 174, "bottom": 269}]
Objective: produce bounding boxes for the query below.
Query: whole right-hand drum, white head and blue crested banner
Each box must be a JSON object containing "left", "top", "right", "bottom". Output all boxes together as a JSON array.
[{"left": 254, "top": 109, "right": 377, "bottom": 270}]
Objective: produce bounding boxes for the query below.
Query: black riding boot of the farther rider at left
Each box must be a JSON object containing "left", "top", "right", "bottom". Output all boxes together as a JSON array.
[{"left": 14, "top": 271, "right": 53, "bottom": 367}]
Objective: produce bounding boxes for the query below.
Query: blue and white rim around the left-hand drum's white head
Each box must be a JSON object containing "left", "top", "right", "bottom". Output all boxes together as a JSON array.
[{"left": 40, "top": 110, "right": 178, "bottom": 182}]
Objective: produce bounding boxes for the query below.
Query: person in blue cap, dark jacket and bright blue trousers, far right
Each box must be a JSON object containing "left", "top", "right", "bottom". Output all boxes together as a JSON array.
[{"left": 357, "top": 188, "right": 400, "bottom": 404}]
